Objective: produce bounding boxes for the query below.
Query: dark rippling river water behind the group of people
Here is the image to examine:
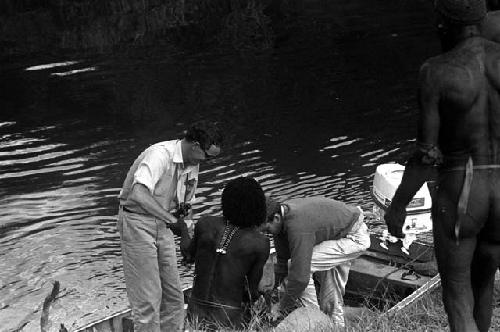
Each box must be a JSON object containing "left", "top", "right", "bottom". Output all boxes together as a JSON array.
[{"left": 0, "top": 0, "right": 439, "bottom": 331}]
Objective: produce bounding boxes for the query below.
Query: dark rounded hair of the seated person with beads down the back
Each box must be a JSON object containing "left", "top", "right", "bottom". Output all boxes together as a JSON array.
[{"left": 222, "top": 177, "right": 266, "bottom": 228}]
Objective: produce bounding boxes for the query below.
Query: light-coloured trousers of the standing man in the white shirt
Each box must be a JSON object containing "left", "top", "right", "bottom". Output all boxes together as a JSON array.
[{"left": 118, "top": 208, "right": 184, "bottom": 332}]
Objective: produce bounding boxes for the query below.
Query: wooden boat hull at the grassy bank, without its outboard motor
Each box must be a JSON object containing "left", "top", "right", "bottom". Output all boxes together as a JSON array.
[{"left": 74, "top": 236, "right": 439, "bottom": 332}]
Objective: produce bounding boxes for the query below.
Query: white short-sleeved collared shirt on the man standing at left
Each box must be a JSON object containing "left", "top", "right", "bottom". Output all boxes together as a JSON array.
[{"left": 119, "top": 140, "right": 199, "bottom": 213}]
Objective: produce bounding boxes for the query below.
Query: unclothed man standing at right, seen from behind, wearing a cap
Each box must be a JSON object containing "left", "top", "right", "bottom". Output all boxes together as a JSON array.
[{"left": 385, "top": 0, "right": 500, "bottom": 332}]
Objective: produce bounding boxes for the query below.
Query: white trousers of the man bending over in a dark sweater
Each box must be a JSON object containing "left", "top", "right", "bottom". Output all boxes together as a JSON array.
[{"left": 300, "top": 207, "right": 370, "bottom": 326}]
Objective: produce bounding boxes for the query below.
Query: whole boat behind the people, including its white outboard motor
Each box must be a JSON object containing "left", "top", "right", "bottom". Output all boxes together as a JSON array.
[{"left": 75, "top": 164, "right": 440, "bottom": 332}]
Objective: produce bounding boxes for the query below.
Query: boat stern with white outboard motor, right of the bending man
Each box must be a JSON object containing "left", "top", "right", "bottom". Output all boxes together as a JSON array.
[{"left": 352, "top": 163, "right": 439, "bottom": 306}]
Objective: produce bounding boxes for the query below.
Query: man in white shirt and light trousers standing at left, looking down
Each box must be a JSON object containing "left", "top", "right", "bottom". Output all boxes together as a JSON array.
[{"left": 118, "top": 122, "right": 222, "bottom": 332}]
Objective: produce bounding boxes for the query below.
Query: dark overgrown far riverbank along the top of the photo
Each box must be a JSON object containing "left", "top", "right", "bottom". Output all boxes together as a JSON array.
[{"left": 0, "top": 0, "right": 432, "bottom": 63}]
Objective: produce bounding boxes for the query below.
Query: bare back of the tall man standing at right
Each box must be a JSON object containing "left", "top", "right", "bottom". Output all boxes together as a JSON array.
[{"left": 419, "top": 37, "right": 500, "bottom": 164}]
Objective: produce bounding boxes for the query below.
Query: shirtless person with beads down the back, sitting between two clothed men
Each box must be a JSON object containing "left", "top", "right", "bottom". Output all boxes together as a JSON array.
[{"left": 181, "top": 177, "right": 270, "bottom": 329}]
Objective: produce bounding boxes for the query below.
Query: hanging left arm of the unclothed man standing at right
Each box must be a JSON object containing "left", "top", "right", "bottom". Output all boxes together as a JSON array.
[{"left": 385, "top": 64, "right": 442, "bottom": 237}]
